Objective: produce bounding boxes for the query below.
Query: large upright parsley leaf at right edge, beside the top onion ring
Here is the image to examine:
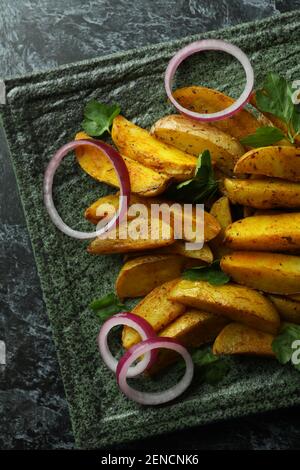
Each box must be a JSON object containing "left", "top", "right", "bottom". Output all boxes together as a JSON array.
[{"left": 256, "top": 72, "right": 300, "bottom": 143}]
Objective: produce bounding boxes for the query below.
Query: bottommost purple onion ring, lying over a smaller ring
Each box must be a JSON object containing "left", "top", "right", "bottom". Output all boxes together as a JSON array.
[{"left": 117, "top": 337, "right": 194, "bottom": 405}]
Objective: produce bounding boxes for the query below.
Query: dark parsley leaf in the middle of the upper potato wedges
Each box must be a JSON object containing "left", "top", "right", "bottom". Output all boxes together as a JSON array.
[{"left": 168, "top": 150, "right": 219, "bottom": 204}]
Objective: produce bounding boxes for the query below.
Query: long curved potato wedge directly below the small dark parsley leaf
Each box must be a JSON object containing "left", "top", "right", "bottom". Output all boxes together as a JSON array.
[{"left": 169, "top": 279, "right": 280, "bottom": 333}]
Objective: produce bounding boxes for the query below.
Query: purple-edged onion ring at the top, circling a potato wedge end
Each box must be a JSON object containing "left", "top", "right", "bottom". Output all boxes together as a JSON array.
[{"left": 165, "top": 39, "right": 254, "bottom": 122}]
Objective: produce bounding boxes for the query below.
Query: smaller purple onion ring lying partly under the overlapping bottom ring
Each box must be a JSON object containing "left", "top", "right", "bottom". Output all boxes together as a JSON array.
[{"left": 98, "top": 312, "right": 157, "bottom": 377}]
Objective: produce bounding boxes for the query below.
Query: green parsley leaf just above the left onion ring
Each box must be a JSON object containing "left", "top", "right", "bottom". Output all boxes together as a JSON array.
[{"left": 82, "top": 100, "right": 121, "bottom": 137}]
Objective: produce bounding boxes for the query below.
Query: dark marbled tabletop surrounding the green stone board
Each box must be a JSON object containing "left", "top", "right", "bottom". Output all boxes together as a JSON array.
[{"left": 0, "top": 0, "right": 300, "bottom": 450}]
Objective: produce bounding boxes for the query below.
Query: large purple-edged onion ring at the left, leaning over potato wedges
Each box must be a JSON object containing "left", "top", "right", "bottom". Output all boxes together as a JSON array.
[{"left": 44, "top": 139, "right": 130, "bottom": 240}]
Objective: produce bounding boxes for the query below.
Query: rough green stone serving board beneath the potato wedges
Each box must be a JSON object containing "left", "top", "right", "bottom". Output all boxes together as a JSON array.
[{"left": 1, "top": 11, "right": 300, "bottom": 448}]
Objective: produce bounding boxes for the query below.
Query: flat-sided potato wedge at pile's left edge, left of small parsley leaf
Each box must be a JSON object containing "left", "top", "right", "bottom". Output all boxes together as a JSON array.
[{"left": 116, "top": 254, "right": 184, "bottom": 299}]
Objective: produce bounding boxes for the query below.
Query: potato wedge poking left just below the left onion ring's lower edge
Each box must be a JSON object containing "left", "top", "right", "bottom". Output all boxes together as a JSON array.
[{"left": 87, "top": 220, "right": 174, "bottom": 255}]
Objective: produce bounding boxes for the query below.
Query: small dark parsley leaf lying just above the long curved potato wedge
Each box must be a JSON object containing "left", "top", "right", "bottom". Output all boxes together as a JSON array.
[{"left": 182, "top": 260, "right": 230, "bottom": 286}]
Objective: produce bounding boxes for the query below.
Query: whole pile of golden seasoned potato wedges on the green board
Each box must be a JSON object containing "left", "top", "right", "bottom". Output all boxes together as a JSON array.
[{"left": 76, "top": 83, "right": 300, "bottom": 373}]
